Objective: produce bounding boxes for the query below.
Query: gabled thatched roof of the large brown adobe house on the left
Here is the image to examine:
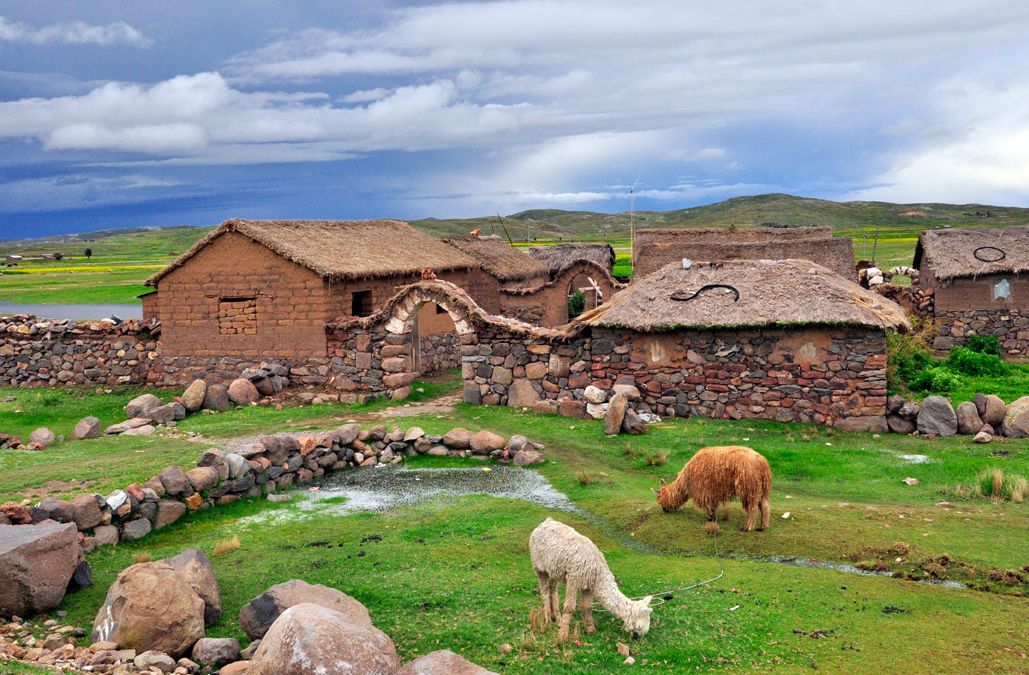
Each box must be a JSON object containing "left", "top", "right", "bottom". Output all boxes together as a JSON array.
[{"left": 146, "top": 219, "right": 475, "bottom": 286}]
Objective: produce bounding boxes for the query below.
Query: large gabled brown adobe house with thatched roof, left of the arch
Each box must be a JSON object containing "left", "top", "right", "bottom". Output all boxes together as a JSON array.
[{"left": 144, "top": 219, "right": 475, "bottom": 358}]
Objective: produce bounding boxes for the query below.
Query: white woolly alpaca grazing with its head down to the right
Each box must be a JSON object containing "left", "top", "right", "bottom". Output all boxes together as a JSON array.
[{"left": 529, "top": 519, "right": 652, "bottom": 642}]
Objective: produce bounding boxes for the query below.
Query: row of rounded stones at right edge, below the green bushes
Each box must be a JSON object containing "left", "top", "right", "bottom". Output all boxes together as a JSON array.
[{"left": 886, "top": 393, "right": 1029, "bottom": 443}]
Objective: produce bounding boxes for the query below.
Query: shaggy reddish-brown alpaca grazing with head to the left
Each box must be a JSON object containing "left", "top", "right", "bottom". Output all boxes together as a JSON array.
[{"left": 658, "top": 446, "right": 772, "bottom": 532}]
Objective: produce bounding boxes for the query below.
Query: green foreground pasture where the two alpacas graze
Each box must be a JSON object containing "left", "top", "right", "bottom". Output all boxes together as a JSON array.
[{"left": 0, "top": 390, "right": 1029, "bottom": 673}]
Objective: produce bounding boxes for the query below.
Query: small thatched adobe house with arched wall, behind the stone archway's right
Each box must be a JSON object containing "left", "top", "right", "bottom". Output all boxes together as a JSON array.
[{"left": 442, "top": 236, "right": 619, "bottom": 326}]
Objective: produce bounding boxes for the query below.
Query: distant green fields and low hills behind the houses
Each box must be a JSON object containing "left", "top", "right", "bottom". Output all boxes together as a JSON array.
[{"left": 0, "top": 194, "right": 1029, "bottom": 304}]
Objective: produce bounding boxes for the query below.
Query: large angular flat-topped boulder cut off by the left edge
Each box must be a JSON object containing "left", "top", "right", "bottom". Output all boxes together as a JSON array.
[{"left": 0, "top": 523, "right": 79, "bottom": 616}]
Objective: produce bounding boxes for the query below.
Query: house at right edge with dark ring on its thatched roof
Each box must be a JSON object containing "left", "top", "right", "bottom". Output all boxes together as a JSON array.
[{"left": 914, "top": 226, "right": 1029, "bottom": 359}]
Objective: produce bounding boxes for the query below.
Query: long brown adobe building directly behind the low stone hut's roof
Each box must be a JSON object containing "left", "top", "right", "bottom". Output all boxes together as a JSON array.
[{"left": 633, "top": 226, "right": 857, "bottom": 281}]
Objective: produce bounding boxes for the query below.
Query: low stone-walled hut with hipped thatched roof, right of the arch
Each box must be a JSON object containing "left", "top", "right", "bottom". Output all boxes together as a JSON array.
[{"left": 572, "top": 259, "right": 909, "bottom": 430}]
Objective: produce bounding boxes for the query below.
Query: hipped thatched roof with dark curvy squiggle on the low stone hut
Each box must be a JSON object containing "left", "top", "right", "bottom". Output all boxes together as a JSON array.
[{"left": 580, "top": 260, "right": 909, "bottom": 332}]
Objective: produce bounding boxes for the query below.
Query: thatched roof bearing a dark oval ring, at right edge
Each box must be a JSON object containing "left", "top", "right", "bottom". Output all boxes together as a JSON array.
[{"left": 914, "top": 225, "right": 1029, "bottom": 281}]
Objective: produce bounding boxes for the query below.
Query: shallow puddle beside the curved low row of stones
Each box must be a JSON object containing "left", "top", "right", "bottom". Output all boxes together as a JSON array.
[{"left": 243, "top": 465, "right": 579, "bottom": 523}]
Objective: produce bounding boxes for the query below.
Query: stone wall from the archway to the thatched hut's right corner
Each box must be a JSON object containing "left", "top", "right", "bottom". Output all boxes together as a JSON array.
[{"left": 462, "top": 327, "right": 886, "bottom": 429}]
